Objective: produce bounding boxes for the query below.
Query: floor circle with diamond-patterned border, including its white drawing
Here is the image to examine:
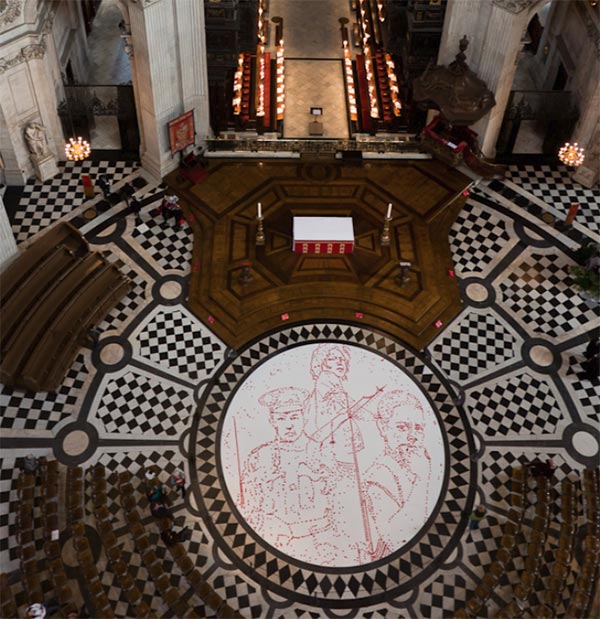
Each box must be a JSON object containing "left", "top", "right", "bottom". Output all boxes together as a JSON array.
[{"left": 190, "top": 323, "right": 475, "bottom": 608}]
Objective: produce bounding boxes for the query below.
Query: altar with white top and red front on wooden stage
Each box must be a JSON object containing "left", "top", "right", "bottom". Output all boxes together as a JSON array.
[{"left": 293, "top": 217, "right": 354, "bottom": 255}]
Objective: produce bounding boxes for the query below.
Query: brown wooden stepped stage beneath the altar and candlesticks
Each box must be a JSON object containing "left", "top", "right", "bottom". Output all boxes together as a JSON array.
[{"left": 165, "top": 159, "right": 470, "bottom": 349}]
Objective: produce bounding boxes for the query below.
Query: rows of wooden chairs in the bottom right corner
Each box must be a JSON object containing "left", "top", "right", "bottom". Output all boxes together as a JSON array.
[{"left": 454, "top": 467, "right": 600, "bottom": 619}]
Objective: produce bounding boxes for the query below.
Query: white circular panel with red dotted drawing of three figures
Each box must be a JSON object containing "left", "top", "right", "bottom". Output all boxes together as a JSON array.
[{"left": 221, "top": 343, "right": 445, "bottom": 567}]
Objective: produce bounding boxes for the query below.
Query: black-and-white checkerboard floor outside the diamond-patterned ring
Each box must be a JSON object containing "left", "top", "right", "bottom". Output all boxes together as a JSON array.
[{"left": 0, "top": 163, "right": 600, "bottom": 619}]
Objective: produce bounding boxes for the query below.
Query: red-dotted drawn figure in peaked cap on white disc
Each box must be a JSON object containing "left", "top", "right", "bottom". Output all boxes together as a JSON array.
[{"left": 242, "top": 387, "right": 339, "bottom": 561}]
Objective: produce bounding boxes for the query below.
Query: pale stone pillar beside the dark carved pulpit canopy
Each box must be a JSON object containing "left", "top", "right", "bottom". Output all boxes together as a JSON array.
[{"left": 473, "top": 0, "right": 534, "bottom": 157}]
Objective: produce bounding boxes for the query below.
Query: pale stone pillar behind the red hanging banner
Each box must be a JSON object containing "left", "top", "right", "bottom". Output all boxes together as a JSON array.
[{"left": 129, "top": 0, "right": 210, "bottom": 178}]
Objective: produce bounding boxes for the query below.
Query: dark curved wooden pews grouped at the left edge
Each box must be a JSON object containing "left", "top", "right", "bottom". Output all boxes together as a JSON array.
[{"left": 0, "top": 222, "right": 131, "bottom": 391}]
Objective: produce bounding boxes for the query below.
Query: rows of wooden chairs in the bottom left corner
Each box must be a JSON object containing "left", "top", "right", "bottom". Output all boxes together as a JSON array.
[{"left": 0, "top": 459, "right": 242, "bottom": 619}]
